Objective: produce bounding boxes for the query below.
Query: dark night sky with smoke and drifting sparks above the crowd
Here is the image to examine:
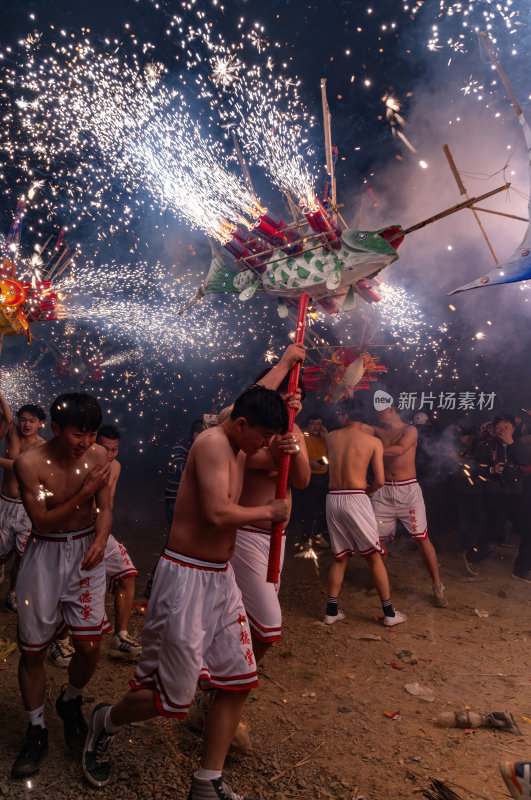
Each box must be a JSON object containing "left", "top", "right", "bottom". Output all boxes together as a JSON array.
[{"left": 0, "top": 0, "right": 531, "bottom": 472}]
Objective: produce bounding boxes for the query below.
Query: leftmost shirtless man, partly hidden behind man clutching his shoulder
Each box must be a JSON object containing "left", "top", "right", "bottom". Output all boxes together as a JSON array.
[{"left": 0, "top": 392, "right": 46, "bottom": 612}]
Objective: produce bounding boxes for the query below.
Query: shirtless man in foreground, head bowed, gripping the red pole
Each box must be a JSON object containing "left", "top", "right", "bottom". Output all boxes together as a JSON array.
[{"left": 83, "top": 386, "right": 288, "bottom": 800}]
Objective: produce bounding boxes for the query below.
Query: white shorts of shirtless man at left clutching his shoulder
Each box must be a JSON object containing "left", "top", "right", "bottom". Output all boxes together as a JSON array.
[{"left": 17, "top": 526, "right": 111, "bottom": 655}]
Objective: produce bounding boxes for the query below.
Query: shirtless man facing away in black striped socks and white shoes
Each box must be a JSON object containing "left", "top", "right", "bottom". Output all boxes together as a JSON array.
[{"left": 324, "top": 403, "right": 407, "bottom": 627}]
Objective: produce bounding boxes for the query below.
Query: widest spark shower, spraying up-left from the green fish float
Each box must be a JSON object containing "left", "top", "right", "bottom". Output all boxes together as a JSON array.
[{"left": 1, "top": 38, "right": 259, "bottom": 239}]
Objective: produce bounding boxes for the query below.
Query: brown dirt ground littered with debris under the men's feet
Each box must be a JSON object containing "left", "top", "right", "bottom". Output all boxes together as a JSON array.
[{"left": 0, "top": 528, "right": 531, "bottom": 800}]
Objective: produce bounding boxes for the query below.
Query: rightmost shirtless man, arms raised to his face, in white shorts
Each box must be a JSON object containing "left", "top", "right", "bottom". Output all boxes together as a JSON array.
[{"left": 372, "top": 405, "right": 448, "bottom": 608}]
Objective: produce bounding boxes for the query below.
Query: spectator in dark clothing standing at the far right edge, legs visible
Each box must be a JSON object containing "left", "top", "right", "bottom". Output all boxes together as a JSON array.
[{"left": 465, "top": 415, "right": 531, "bottom": 580}]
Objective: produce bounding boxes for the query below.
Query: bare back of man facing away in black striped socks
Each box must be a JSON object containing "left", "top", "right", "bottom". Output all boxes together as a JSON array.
[{"left": 326, "top": 422, "right": 383, "bottom": 490}]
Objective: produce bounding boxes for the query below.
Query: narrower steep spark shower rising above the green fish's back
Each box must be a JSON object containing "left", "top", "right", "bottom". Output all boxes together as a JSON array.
[{"left": 162, "top": 6, "right": 317, "bottom": 205}]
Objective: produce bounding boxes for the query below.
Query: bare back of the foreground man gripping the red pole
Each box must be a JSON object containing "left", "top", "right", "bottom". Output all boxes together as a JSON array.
[{"left": 168, "top": 427, "right": 245, "bottom": 561}]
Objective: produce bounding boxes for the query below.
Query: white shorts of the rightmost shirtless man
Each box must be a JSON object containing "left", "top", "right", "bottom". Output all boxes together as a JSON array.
[{"left": 372, "top": 478, "right": 428, "bottom": 542}]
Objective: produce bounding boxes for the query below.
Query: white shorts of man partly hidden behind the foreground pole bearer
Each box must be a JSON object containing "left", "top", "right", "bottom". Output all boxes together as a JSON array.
[{"left": 230, "top": 525, "right": 286, "bottom": 642}]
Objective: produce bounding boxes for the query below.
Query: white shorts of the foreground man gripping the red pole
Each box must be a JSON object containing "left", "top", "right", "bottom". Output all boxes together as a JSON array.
[{"left": 130, "top": 547, "right": 258, "bottom": 719}]
